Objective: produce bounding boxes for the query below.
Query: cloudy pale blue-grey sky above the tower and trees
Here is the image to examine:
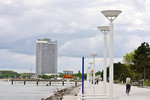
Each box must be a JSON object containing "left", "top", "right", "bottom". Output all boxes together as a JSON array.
[{"left": 0, "top": 0, "right": 150, "bottom": 73}]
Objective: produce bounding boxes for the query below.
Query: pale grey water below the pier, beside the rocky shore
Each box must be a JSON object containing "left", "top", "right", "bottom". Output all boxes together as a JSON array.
[{"left": 0, "top": 81, "right": 65, "bottom": 100}]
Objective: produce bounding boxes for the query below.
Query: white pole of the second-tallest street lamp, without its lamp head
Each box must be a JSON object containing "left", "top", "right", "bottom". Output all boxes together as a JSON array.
[{"left": 103, "top": 32, "right": 107, "bottom": 94}]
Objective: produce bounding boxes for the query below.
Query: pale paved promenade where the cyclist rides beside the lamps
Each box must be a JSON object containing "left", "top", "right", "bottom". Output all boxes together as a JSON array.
[{"left": 85, "top": 82, "right": 150, "bottom": 100}]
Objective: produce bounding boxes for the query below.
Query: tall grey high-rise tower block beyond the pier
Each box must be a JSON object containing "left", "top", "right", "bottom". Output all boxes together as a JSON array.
[{"left": 36, "top": 38, "right": 58, "bottom": 75}]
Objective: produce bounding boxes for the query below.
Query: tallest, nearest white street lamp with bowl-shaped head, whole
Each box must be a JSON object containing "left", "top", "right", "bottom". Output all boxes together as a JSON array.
[{"left": 101, "top": 10, "right": 122, "bottom": 100}]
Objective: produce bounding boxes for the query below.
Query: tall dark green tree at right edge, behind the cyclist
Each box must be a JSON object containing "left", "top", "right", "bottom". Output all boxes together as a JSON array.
[{"left": 132, "top": 42, "right": 150, "bottom": 82}]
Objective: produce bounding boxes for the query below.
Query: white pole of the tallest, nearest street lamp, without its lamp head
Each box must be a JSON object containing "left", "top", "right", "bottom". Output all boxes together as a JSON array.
[{"left": 109, "top": 20, "right": 114, "bottom": 100}]
